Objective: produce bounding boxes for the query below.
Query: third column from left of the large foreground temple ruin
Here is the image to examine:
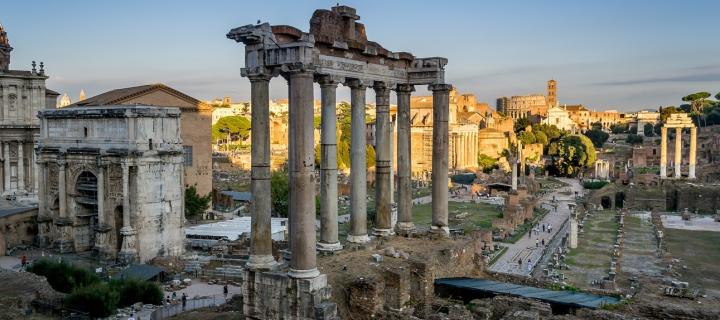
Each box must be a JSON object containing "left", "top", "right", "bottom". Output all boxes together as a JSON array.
[{"left": 317, "top": 77, "right": 342, "bottom": 251}]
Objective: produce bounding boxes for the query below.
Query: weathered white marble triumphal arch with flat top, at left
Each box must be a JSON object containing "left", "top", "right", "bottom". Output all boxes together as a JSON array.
[{"left": 37, "top": 106, "right": 185, "bottom": 263}]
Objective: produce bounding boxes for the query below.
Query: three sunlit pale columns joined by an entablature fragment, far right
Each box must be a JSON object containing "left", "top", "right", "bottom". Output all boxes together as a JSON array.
[{"left": 660, "top": 113, "right": 697, "bottom": 179}]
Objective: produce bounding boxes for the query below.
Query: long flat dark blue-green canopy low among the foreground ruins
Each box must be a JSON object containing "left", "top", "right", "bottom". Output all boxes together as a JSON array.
[{"left": 435, "top": 278, "right": 620, "bottom": 309}]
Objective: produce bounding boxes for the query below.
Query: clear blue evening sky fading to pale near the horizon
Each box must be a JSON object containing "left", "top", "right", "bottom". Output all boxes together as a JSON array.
[{"left": 0, "top": 0, "right": 720, "bottom": 110}]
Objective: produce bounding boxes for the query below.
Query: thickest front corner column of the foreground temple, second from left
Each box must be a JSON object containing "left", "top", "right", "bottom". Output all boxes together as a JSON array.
[{"left": 287, "top": 70, "right": 320, "bottom": 278}]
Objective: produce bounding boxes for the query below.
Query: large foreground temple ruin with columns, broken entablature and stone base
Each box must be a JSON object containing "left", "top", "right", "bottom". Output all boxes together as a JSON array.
[{"left": 227, "top": 6, "right": 451, "bottom": 319}]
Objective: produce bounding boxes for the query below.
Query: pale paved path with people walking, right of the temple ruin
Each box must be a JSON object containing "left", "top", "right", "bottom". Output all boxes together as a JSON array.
[{"left": 490, "top": 178, "right": 582, "bottom": 276}]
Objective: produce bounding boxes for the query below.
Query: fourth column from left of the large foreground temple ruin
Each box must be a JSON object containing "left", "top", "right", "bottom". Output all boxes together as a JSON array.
[{"left": 347, "top": 80, "right": 370, "bottom": 243}]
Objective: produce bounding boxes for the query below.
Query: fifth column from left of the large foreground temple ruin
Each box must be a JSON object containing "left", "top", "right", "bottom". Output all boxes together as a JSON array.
[{"left": 373, "top": 82, "right": 393, "bottom": 236}]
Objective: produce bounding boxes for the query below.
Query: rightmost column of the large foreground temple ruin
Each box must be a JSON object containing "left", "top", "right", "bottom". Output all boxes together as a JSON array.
[{"left": 429, "top": 84, "right": 452, "bottom": 235}]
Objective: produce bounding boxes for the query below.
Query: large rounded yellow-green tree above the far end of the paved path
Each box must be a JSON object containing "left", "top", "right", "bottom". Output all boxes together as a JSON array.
[{"left": 550, "top": 134, "right": 596, "bottom": 177}]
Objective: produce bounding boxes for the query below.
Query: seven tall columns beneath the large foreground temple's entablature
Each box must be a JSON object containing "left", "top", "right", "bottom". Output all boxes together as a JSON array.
[{"left": 248, "top": 70, "right": 451, "bottom": 278}]
